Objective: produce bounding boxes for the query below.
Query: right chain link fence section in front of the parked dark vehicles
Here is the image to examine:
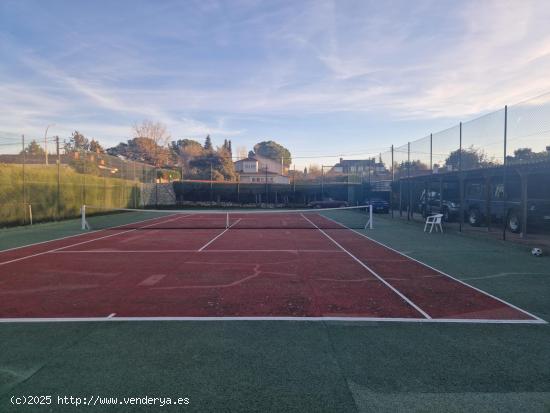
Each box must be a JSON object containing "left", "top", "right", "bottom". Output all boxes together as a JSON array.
[{"left": 382, "top": 93, "right": 550, "bottom": 241}]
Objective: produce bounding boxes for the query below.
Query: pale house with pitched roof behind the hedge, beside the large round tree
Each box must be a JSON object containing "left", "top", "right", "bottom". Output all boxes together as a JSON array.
[{"left": 235, "top": 155, "right": 290, "bottom": 184}]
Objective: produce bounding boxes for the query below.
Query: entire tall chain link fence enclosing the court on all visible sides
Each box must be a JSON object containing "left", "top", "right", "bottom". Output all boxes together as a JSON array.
[{"left": 0, "top": 93, "right": 550, "bottom": 238}]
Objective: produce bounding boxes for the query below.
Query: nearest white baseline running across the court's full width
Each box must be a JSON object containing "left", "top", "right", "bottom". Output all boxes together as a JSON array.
[{"left": 0, "top": 314, "right": 547, "bottom": 324}]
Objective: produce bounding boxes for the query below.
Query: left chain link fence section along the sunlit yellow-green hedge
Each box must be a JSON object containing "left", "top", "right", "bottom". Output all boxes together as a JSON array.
[{"left": 0, "top": 133, "right": 175, "bottom": 227}]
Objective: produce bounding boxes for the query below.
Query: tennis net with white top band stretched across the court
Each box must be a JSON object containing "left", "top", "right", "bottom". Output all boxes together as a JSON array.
[{"left": 81, "top": 205, "right": 372, "bottom": 230}]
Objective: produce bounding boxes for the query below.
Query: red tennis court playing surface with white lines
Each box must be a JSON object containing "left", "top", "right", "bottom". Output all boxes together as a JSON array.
[{"left": 0, "top": 214, "right": 544, "bottom": 323}]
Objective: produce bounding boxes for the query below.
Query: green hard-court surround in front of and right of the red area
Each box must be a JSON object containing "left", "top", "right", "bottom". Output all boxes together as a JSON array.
[{"left": 0, "top": 211, "right": 550, "bottom": 412}]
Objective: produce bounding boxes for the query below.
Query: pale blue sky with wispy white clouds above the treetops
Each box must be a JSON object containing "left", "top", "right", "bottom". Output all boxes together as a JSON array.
[{"left": 0, "top": 0, "right": 550, "bottom": 167}]
